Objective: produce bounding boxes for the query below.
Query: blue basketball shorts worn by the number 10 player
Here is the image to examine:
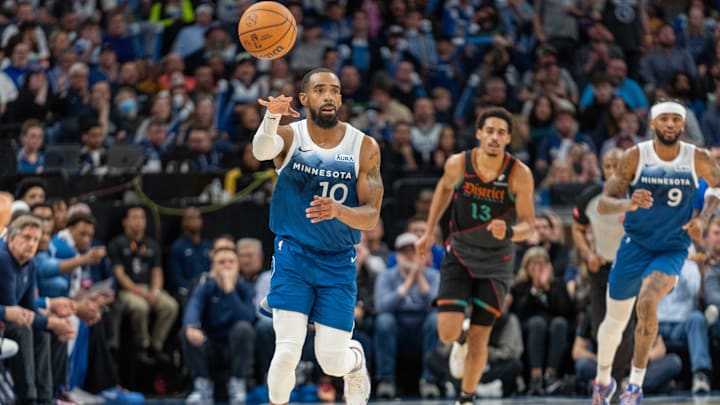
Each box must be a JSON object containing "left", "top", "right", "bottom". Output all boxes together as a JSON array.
[{"left": 267, "top": 237, "right": 357, "bottom": 332}]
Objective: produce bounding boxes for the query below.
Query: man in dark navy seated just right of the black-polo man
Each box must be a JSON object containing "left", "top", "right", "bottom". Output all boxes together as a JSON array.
[{"left": 169, "top": 207, "right": 212, "bottom": 303}]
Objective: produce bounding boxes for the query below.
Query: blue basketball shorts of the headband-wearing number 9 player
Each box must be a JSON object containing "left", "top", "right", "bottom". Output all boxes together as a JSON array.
[{"left": 608, "top": 235, "right": 688, "bottom": 300}]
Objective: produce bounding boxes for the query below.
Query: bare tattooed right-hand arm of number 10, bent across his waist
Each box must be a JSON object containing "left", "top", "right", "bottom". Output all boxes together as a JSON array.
[{"left": 305, "top": 136, "right": 384, "bottom": 230}]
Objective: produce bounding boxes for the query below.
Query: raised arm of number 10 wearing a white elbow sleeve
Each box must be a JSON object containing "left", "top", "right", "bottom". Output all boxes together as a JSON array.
[{"left": 253, "top": 95, "right": 300, "bottom": 167}]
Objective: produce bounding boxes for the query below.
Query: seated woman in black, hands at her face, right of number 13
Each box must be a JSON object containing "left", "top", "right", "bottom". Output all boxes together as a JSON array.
[{"left": 510, "top": 247, "right": 574, "bottom": 395}]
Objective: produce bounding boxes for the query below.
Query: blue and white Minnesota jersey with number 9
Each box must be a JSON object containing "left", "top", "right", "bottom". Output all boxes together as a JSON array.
[{"left": 624, "top": 141, "right": 698, "bottom": 251}]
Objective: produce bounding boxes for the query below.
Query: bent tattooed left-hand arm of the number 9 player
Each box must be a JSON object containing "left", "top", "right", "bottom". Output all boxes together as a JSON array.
[{"left": 598, "top": 146, "right": 652, "bottom": 214}]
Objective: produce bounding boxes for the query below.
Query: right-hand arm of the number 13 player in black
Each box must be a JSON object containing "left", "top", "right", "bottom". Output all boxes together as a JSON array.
[{"left": 510, "top": 161, "right": 535, "bottom": 242}]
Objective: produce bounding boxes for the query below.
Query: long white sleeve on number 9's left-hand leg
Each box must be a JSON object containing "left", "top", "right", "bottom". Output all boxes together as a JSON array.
[{"left": 596, "top": 293, "right": 635, "bottom": 385}]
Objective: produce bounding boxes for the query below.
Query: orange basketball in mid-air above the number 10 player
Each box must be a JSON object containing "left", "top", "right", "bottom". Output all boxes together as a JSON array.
[{"left": 238, "top": 1, "right": 297, "bottom": 60}]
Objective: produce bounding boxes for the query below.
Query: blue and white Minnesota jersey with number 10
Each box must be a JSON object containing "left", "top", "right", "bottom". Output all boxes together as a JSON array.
[{"left": 270, "top": 120, "right": 365, "bottom": 253}]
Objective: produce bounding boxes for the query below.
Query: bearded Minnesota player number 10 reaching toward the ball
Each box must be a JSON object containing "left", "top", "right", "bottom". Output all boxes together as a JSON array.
[{"left": 253, "top": 68, "right": 383, "bottom": 405}]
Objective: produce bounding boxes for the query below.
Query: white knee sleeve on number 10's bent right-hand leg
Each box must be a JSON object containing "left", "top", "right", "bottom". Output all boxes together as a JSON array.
[{"left": 315, "top": 323, "right": 358, "bottom": 377}]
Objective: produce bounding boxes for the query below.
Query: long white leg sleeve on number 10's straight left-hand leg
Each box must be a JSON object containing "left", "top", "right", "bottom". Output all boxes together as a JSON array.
[{"left": 268, "top": 310, "right": 308, "bottom": 404}]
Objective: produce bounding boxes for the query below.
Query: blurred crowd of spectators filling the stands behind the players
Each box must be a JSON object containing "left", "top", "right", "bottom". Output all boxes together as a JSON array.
[{"left": 0, "top": 0, "right": 720, "bottom": 403}]
